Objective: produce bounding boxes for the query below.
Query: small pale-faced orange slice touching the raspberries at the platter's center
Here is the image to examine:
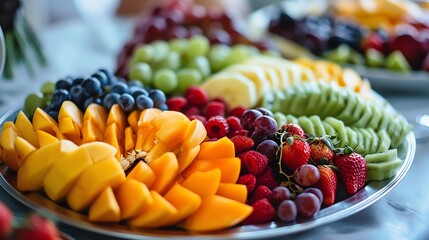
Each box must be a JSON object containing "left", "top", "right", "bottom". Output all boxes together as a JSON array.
[{"left": 181, "top": 119, "right": 207, "bottom": 150}]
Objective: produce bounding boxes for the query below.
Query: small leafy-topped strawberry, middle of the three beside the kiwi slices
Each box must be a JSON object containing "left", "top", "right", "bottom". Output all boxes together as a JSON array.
[{"left": 308, "top": 137, "right": 334, "bottom": 164}]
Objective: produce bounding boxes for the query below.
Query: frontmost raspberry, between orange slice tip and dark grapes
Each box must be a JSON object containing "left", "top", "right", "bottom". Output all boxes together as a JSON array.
[{"left": 242, "top": 199, "right": 276, "bottom": 225}]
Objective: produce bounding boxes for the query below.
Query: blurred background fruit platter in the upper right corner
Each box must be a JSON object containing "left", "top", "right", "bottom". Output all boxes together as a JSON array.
[{"left": 249, "top": 0, "right": 429, "bottom": 92}]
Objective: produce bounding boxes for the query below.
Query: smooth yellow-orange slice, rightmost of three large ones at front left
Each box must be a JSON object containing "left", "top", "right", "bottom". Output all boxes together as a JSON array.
[{"left": 67, "top": 158, "right": 125, "bottom": 211}]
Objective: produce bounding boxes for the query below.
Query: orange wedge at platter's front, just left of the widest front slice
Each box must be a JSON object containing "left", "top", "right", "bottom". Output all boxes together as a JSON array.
[{"left": 128, "top": 190, "right": 177, "bottom": 228}]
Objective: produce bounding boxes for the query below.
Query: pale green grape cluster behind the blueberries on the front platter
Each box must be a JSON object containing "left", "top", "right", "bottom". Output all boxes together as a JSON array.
[{"left": 127, "top": 35, "right": 275, "bottom": 94}]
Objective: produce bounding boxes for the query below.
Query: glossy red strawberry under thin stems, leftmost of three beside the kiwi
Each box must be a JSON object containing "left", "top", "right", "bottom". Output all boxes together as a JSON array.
[{"left": 281, "top": 137, "right": 310, "bottom": 171}]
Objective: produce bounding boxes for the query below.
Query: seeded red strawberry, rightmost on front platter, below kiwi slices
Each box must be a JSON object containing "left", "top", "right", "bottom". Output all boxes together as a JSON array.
[{"left": 334, "top": 152, "right": 366, "bottom": 194}]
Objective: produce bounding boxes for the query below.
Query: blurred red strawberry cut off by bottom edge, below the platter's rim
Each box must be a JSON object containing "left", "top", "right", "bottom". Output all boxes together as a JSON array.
[{"left": 16, "top": 214, "right": 60, "bottom": 240}]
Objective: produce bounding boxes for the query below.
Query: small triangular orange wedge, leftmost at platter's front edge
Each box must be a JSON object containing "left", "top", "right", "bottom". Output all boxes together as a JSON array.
[{"left": 89, "top": 187, "right": 121, "bottom": 222}]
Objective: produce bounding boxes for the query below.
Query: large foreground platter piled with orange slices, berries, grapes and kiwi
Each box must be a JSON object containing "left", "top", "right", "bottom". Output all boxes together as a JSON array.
[{"left": 0, "top": 1, "right": 415, "bottom": 239}]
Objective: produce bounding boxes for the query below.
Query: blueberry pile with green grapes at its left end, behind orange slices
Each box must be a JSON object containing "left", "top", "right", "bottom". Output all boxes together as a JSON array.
[{"left": 24, "top": 69, "right": 168, "bottom": 120}]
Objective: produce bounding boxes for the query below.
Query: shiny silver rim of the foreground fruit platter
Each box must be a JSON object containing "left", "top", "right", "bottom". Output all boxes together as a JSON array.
[{"left": 0, "top": 105, "right": 416, "bottom": 239}]
